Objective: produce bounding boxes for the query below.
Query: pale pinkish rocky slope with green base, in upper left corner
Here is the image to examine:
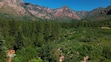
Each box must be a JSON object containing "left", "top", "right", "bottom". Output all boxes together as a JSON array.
[{"left": 0, "top": 0, "right": 27, "bottom": 15}]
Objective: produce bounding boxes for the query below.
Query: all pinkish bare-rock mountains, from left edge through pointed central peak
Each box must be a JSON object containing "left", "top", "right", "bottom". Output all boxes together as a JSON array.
[{"left": 0, "top": 0, "right": 81, "bottom": 20}]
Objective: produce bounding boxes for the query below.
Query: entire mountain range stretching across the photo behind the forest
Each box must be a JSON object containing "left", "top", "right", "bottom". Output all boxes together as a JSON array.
[{"left": 0, "top": 0, "right": 111, "bottom": 20}]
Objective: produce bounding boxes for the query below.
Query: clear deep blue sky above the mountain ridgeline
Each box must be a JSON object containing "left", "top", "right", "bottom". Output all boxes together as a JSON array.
[{"left": 24, "top": 0, "right": 111, "bottom": 11}]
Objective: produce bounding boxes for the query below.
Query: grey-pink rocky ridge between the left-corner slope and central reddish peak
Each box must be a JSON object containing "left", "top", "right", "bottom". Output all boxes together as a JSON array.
[{"left": 25, "top": 3, "right": 52, "bottom": 19}]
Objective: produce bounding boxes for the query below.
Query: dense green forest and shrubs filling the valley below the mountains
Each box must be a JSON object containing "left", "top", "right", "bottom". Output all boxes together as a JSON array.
[{"left": 0, "top": 18, "right": 111, "bottom": 62}]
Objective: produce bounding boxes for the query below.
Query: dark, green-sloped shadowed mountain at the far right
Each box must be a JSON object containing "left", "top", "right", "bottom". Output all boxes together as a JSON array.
[{"left": 86, "top": 6, "right": 111, "bottom": 21}]
